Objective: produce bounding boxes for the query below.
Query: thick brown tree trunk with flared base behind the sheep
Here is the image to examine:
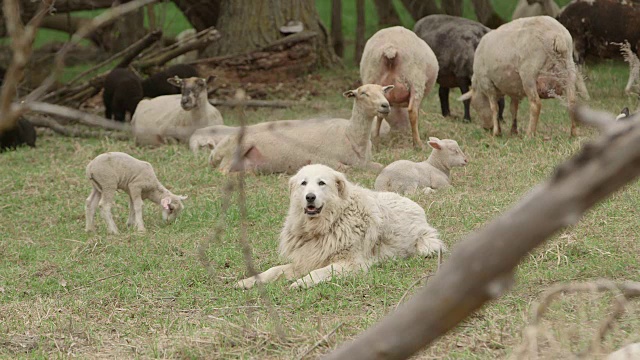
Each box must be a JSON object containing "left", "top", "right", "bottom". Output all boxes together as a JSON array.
[{"left": 204, "top": 0, "right": 339, "bottom": 66}]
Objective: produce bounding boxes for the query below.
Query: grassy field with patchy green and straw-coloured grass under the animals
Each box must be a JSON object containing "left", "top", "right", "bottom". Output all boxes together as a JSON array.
[{"left": 0, "top": 0, "right": 640, "bottom": 359}]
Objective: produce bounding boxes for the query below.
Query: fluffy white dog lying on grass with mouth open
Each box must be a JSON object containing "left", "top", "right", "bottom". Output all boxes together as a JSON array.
[{"left": 236, "top": 164, "right": 445, "bottom": 289}]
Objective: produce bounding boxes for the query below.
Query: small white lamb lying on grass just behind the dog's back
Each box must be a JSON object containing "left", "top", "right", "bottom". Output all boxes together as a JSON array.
[{"left": 374, "top": 137, "right": 469, "bottom": 194}]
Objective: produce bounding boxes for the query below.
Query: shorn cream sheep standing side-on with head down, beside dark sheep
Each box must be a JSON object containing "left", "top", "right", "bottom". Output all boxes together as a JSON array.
[{"left": 459, "top": 16, "right": 579, "bottom": 136}]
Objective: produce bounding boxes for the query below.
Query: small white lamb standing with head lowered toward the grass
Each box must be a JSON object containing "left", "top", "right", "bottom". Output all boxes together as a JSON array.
[{"left": 85, "top": 152, "right": 187, "bottom": 234}]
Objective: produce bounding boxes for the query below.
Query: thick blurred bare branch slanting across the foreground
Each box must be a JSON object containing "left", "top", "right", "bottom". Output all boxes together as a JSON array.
[{"left": 326, "top": 108, "right": 640, "bottom": 359}]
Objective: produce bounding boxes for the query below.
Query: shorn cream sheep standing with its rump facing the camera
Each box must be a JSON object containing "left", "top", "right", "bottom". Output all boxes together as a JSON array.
[{"left": 360, "top": 26, "right": 438, "bottom": 147}]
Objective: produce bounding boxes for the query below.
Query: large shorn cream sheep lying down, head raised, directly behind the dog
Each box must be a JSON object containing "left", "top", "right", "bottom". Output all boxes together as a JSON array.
[{"left": 209, "top": 84, "right": 393, "bottom": 174}]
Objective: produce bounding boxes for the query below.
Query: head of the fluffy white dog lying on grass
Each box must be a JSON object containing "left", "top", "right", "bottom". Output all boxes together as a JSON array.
[{"left": 289, "top": 164, "right": 348, "bottom": 218}]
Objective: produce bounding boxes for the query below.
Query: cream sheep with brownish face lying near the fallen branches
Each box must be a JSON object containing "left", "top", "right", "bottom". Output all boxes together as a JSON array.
[{"left": 131, "top": 76, "right": 223, "bottom": 145}]
